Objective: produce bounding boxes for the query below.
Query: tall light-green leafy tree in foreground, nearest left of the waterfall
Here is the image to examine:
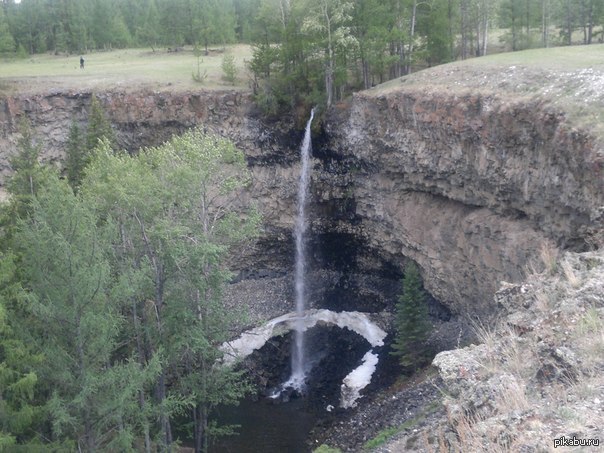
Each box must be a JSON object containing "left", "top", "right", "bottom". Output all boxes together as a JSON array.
[{"left": 82, "top": 131, "right": 258, "bottom": 451}]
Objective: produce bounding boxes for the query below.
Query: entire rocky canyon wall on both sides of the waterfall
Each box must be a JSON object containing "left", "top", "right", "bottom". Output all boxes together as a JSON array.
[{"left": 0, "top": 84, "right": 604, "bottom": 319}]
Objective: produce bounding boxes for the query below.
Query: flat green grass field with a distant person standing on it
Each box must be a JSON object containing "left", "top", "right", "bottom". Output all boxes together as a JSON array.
[{"left": 0, "top": 45, "right": 251, "bottom": 92}]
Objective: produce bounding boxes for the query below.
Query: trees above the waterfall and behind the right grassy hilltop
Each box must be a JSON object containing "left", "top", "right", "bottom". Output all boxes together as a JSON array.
[{"left": 245, "top": 0, "right": 604, "bottom": 113}]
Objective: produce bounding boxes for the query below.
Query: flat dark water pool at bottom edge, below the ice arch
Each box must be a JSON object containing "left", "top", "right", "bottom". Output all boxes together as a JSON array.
[{"left": 210, "top": 398, "right": 317, "bottom": 453}]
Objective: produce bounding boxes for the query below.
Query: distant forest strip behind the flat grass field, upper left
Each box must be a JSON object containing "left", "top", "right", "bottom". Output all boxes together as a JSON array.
[{"left": 0, "top": 0, "right": 241, "bottom": 54}]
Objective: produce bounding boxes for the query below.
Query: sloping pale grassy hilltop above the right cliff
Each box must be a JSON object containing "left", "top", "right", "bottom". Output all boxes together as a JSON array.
[{"left": 368, "top": 44, "right": 604, "bottom": 138}]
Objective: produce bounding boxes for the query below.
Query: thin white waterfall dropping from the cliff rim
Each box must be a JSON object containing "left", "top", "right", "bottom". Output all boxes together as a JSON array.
[{"left": 288, "top": 109, "right": 315, "bottom": 390}]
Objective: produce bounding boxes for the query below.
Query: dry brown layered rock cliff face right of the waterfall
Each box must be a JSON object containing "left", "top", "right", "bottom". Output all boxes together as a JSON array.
[{"left": 327, "top": 86, "right": 604, "bottom": 314}]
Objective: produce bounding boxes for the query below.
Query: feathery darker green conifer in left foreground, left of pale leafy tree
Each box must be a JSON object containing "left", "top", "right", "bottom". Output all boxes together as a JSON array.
[{"left": 16, "top": 178, "right": 157, "bottom": 451}]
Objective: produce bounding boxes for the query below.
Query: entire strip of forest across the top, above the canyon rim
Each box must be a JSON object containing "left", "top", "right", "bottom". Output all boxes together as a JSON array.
[{"left": 0, "top": 0, "right": 604, "bottom": 109}]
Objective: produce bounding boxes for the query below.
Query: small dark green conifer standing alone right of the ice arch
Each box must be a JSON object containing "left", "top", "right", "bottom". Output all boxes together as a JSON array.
[{"left": 391, "top": 262, "right": 432, "bottom": 371}]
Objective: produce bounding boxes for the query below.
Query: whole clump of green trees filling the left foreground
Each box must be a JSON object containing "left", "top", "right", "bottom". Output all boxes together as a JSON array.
[{"left": 0, "top": 98, "right": 259, "bottom": 452}]
